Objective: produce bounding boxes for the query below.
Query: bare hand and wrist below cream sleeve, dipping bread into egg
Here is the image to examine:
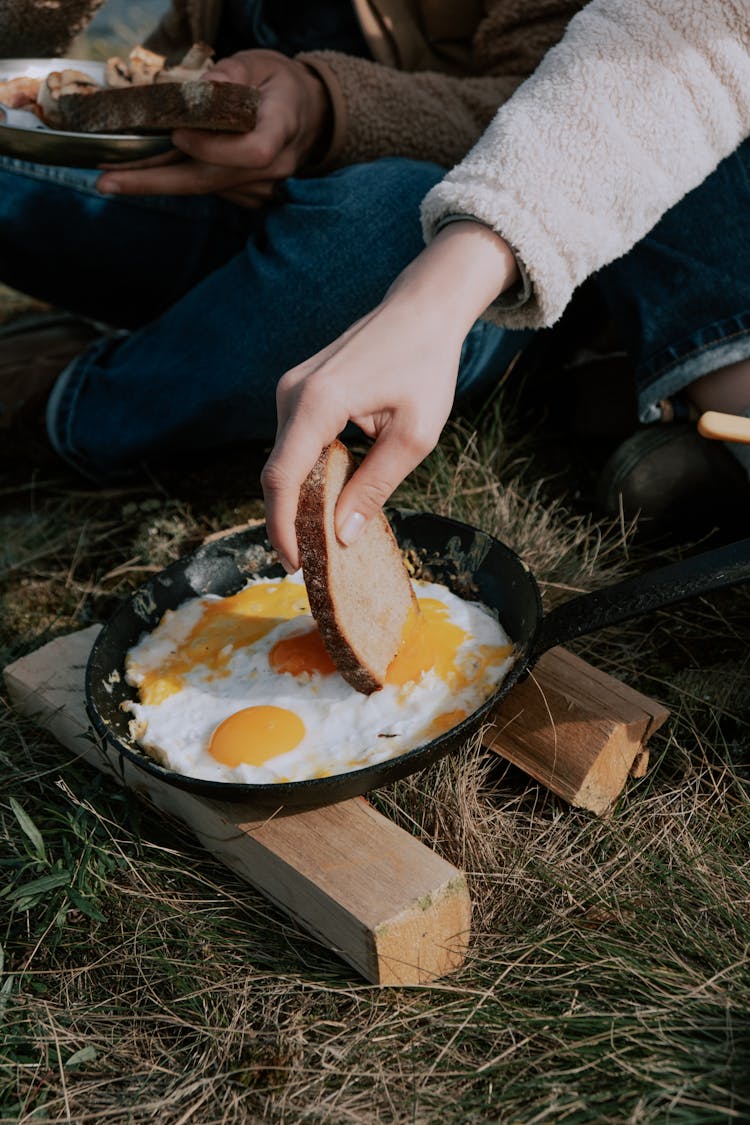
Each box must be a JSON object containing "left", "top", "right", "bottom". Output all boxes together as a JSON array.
[{"left": 261, "top": 222, "right": 517, "bottom": 569}]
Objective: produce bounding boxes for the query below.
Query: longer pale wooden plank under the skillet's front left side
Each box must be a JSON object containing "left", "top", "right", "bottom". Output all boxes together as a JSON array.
[{"left": 4, "top": 626, "right": 471, "bottom": 984}]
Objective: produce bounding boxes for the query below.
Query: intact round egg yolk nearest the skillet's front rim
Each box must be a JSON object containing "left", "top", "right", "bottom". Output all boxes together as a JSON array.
[{"left": 208, "top": 707, "right": 305, "bottom": 767}]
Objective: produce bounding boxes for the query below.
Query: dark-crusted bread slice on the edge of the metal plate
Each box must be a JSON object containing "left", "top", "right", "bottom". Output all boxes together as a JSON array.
[{"left": 53, "top": 80, "right": 261, "bottom": 133}]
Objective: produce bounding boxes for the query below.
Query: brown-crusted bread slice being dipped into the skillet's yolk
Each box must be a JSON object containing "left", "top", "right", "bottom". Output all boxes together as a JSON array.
[{"left": 296, "top": 441, "right": 418, "bottom": 695}]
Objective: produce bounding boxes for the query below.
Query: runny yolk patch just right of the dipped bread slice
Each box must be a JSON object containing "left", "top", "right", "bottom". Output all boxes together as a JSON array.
[{"left": 386, "top": 597, "right": 467, "bottom": 686}]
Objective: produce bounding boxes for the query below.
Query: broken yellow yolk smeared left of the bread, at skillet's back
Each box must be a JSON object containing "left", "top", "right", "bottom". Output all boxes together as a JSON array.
[{"left": 139, "top": 579, "right": 310, "bottom": 704}]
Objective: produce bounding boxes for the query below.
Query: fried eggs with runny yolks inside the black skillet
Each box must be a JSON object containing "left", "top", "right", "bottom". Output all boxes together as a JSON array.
[{"left": 125, "top": 573, "right": 513, "bottom": 784}]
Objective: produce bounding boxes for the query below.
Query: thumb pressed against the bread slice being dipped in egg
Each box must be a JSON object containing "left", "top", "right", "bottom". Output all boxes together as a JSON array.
[{"left": 335, "top": 431, "right": 437, "bottom": 547}]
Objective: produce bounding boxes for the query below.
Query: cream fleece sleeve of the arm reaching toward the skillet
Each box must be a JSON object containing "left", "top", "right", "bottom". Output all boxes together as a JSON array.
[{"left": 422, "top": 0, "right": 750, "bottom": 329}]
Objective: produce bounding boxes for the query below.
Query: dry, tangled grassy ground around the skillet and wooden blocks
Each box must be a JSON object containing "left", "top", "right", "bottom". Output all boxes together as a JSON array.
[{"left": 0, "top": 10, "right": 750, "bottom": 1125}]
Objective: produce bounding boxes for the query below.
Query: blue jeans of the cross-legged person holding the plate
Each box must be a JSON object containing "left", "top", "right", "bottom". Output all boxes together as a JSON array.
[{"left": 0, "top": 159, "right": 526, "bottom": 477}]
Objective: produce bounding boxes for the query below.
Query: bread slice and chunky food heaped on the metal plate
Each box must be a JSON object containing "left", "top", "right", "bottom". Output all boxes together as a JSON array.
[{"left": 0, "top": 44, "right": 260, "bottom": 134}]
